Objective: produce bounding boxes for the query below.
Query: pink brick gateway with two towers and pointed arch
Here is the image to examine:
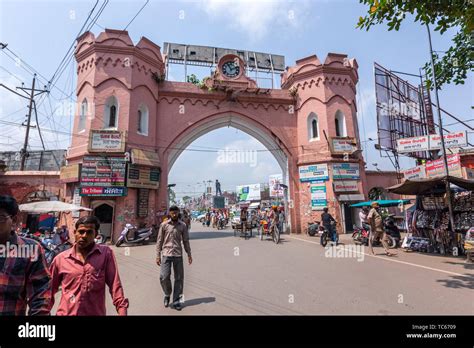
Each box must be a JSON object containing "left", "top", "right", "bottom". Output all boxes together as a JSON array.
[{"left": 61, "top": 29, "right": 393, "bottom": 239}]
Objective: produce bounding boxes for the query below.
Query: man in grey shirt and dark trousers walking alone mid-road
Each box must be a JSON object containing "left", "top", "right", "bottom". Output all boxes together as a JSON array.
[{"left": 156, "top": 205, "right": 193, "bottom": 311}]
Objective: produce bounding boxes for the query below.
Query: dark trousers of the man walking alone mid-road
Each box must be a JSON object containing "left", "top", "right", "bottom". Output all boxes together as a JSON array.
[{"left": 160, "top": 256, "right": 184, "bottom": 302}]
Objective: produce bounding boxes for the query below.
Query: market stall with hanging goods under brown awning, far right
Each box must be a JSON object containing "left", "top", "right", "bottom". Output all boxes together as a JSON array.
[{"left": 387, "top": 176, "right": 474, "bottom": 255}]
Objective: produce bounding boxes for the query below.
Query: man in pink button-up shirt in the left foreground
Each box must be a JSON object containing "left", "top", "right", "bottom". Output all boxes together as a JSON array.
[{"left": 50, "top": 216, "right": 128, "bottom": 315}]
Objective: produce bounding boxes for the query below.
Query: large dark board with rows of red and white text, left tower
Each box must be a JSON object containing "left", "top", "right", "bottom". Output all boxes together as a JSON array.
[{"left": 81, "top": 156, "right": 127, "bottom": 187}]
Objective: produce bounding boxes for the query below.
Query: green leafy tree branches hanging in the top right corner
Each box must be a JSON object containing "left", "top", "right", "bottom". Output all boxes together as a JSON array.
[{"left": 357, "top": 0, "right": 474, "bottom": 89}]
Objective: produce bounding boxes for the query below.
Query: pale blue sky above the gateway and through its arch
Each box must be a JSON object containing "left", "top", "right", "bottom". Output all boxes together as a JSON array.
[{"left": 0, "top": 0, "right": 474, "bottom": 198}]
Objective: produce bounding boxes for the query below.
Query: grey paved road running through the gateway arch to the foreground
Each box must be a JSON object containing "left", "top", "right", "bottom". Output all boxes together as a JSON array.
[{"left": 53, "top": 224, "right": 474, "bottom": 315}]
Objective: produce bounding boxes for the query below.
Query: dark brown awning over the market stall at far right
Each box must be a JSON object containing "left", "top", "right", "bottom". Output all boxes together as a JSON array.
[{"left": 387, "top": 176, "right": 474, "bottom": 195}]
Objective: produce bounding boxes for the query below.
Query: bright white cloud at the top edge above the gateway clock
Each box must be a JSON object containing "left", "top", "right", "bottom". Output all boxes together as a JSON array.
[{"left": 198, "top": 0, "right": 309, "bottom": 41}]
